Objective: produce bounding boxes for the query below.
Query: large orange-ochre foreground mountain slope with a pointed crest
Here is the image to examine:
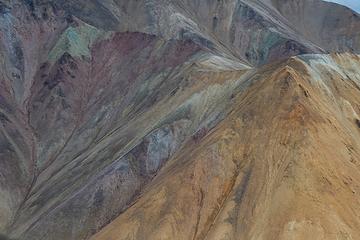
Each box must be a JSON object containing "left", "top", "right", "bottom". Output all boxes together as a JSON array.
[{"left": 92, "top": 55, "right": 360, "bottom": 240}]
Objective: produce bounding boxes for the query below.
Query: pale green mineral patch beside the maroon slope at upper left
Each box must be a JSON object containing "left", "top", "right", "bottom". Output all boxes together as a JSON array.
[{"left": 49, "top": 23, "right": 106, "bottom": 61}]
